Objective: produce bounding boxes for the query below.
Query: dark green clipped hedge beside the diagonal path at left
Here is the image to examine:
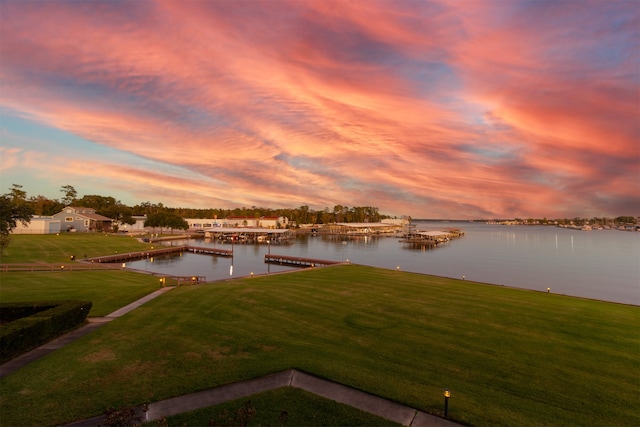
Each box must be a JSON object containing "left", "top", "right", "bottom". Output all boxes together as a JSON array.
[{"left": 0, "top": 301, "right": 92, "bottom": 363}]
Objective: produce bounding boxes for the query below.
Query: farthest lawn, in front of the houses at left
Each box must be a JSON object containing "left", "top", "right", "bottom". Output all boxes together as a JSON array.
[{"left": 0, "top": 233, "right": 150, "bottom": 263}]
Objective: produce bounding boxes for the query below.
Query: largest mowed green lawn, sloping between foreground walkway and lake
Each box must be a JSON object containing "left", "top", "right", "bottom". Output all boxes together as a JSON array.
[{"left": 0, "top": 266, "right": 640, "bottom": 426}]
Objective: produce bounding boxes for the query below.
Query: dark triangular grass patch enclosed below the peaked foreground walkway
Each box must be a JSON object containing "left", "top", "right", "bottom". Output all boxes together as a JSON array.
[{"left": 151, "top": 387, "right": 400, "bottom": 427}]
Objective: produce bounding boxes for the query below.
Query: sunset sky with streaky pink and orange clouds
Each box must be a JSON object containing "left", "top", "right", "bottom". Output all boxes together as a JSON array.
[{"left": 0, "top": 0, "right": 640, "bottom": 219}]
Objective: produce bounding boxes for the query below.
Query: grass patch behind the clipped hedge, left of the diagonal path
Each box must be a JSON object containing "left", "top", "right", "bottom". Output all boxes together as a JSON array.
[{"left": 0, "top": 270, "right": 160, "bottom": 317}]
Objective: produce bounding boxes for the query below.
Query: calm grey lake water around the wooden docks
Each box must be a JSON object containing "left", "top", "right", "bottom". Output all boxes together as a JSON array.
[{"left": 127, "top": 222, "right": 640, "bottom": 305}]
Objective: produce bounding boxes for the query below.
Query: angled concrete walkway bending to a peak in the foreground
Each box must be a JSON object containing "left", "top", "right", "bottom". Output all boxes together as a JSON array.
[{"left": 66, "top": 369, "right": 459, "bottom": 427}]
